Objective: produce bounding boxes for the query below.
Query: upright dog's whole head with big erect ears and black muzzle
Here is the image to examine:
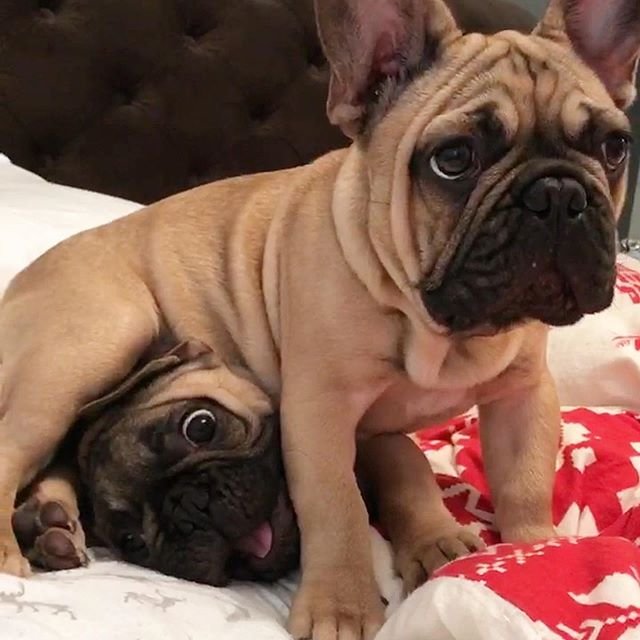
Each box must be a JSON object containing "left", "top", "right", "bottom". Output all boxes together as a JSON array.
[{"left": 316, "top": 0, "right": 640, "bottom": 333}]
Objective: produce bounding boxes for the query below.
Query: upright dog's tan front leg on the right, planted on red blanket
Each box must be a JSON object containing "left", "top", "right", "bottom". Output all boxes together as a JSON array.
[{"left": 480, "top": 372, "right": 560, "bottom": 542}]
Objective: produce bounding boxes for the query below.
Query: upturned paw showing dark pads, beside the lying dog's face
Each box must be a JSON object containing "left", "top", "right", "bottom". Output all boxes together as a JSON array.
[{"left": 12, "top": 496, "right": 88, "bottom": 571}]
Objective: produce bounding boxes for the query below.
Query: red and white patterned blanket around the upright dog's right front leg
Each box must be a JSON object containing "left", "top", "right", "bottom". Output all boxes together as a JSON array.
[{"left": 380, "top": 409, "right": 640, "bottom": 640}]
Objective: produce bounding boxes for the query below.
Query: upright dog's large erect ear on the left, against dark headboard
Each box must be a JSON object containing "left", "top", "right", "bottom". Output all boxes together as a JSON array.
[{"left": 315, "top": 0, "right": 460, "bottom": 138}]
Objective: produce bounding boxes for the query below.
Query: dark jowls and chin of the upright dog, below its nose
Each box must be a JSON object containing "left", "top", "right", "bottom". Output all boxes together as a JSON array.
[{"left": 421, "top": 194, "right": 616, "bottom": 335}]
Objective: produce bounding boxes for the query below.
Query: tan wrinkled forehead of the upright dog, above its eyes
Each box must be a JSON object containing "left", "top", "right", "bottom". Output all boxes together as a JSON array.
[{"left": 410, "top": 31, "right": 630, "bottom": 143}]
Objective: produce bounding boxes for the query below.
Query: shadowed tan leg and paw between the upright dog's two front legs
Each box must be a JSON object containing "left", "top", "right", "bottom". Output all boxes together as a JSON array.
[{"left": 356, "top": 434, "right": 485, "bottom": 593}]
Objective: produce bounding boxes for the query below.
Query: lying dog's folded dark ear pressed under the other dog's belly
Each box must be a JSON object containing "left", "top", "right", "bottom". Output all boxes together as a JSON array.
[{"left": 78, "top": 339, "right": 212, "bottom": 419}]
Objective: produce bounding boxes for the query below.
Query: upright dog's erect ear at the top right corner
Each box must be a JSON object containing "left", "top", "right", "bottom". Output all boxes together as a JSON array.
[{"left": 535, "top": 0, "right": 640, "bottom": 109}]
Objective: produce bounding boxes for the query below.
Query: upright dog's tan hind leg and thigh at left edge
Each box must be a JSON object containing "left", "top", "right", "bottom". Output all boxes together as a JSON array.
[{"left": 0, "top": 292, "right": 157, "bottom": 575}]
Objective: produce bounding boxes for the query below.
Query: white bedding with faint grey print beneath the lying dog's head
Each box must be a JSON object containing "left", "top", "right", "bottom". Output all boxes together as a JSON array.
[{"left": 0, "top": 553, "right": 290, "bottom": 640}]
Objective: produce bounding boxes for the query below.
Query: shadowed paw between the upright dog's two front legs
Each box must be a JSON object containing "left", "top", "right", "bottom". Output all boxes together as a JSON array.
[{"left": 395, "top": 526, "right": 486, "bottom": 594}]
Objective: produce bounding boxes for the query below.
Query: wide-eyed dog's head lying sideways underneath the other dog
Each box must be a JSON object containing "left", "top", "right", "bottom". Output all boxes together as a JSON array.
[{"left": 77, "top": 342, "right": 299, "bottom": 585}]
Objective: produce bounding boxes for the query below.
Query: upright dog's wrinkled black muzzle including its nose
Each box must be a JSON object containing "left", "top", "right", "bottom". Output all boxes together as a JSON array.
[{"left": 421, "top": 165, "right": 616, "bottom": 332}]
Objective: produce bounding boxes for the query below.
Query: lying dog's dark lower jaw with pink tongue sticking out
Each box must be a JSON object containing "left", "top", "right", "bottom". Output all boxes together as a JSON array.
[{"left": 226, "top": 491, "right": 300, "bottom": 582}]
